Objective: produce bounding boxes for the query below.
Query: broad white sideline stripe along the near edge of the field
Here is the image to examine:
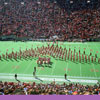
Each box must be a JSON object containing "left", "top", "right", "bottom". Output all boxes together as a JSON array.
[{"left": 0, "top": 76, "right": 98, "bottom": 84}]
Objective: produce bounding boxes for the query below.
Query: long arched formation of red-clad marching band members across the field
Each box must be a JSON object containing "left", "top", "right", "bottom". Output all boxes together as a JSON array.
[{"left": 0, "top": 44, "right": 100, "bottom": 63}]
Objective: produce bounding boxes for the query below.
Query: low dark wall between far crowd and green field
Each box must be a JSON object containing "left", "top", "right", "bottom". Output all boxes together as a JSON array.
[{"left": 0, "top": 35, "right": 100, "bottom": 42}]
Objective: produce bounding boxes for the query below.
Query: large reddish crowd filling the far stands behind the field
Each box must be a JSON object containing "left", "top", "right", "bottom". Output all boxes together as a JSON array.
[{"left": 0, "top": 0, "right": 100, "bottom": 40}]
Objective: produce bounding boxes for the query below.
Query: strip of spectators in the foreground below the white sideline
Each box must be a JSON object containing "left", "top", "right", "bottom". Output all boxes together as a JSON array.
[{"left": 0, "top": 81, "right": 100, "bottom": 95}]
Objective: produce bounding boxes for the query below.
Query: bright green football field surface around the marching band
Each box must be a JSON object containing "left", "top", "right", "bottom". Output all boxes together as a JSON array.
[{"left": 0, "top": 41, "right": 100, "bottom": 84}]
